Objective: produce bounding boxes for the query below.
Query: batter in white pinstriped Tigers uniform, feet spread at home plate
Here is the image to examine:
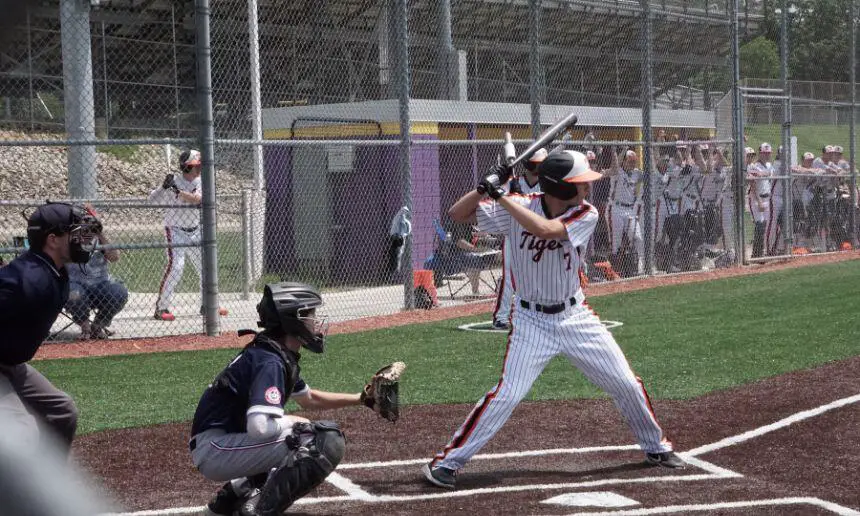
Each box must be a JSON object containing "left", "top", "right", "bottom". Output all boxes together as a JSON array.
[{"left": 422, "top": 151, "right": 684, "bottom": 488}]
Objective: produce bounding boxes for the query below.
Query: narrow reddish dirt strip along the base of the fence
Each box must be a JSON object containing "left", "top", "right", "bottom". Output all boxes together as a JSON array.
[{"left": 36, "top": 251, "right": 860, "bottom": 360}]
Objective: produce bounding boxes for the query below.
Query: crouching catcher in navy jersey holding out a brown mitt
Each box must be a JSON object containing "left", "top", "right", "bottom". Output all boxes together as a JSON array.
[{"left": 189, "top": 282, "right": 405, "bottom": 515}]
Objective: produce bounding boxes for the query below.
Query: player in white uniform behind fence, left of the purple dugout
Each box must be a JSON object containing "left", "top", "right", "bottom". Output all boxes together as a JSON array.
[{"left": 149, "top": 149, "right": 227, "bottom": 321}]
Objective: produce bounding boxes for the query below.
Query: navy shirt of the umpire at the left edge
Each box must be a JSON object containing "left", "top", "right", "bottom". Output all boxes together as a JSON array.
[{"left": 0, "top": 250, "right": 69, "bottom": 366}]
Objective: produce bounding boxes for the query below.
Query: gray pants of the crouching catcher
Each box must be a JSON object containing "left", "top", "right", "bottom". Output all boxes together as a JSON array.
[{"left": 189, "top": 429, "right": 292, "bottom": 481}]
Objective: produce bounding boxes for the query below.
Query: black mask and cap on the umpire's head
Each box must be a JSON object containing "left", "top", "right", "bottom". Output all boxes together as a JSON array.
[{"left": 21, "top": 202, "right": 101, "bottom": 263}]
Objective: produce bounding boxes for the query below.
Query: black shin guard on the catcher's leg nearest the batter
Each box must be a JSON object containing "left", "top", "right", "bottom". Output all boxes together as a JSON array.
[{"left": 257, "top": 421, "right": 346, "bottom": 516}]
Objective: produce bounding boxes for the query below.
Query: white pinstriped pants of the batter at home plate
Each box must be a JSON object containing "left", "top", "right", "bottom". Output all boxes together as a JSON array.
[{"left": 433, "top": 298, "right": 672, "bottom": 470}]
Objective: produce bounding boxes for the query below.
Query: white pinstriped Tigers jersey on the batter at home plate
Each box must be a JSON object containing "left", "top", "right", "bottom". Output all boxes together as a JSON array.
[{"left": 476, "top": 194, "right": 599, "bottom": 304}]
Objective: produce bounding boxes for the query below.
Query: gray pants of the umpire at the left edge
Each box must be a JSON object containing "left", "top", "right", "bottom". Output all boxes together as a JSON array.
[{"left": 0, "top": 364, "right": 78, "bottom": 454}]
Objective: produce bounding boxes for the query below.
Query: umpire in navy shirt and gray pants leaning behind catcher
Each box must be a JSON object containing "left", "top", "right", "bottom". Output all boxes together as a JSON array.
[{"left": 0, "top": 203, "right": 98, "bottom": 453}]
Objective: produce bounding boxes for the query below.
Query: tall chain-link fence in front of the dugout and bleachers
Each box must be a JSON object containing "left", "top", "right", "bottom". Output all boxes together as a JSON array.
[{"left": 0, "top": 0, "right": 855, "bottom": 339}]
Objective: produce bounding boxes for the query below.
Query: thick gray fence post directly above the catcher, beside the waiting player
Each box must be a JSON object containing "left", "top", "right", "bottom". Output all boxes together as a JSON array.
[{"left": 194, "top": 0, "right": 220, "bottom": 337}]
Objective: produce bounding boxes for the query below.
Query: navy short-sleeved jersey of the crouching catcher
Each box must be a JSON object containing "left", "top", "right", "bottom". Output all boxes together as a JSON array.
[{"left": 191, "top": 335, "right": 304, "bottom": 435}]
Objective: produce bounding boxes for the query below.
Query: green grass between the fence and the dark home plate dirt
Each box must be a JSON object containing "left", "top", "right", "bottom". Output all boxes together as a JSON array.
[{"left": 35, "top": 261, "right": 860, "bottom": 432}]
